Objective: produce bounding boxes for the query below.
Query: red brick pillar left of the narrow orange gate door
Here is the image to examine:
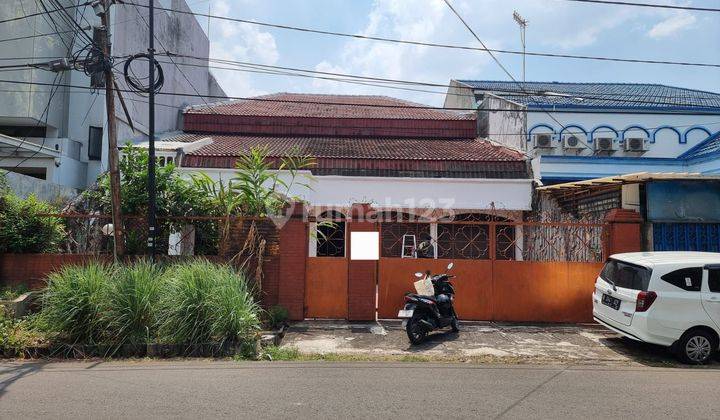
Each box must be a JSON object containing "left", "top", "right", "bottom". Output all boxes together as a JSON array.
[{"left": 278, "top": 219, "right": 308, "bottom": 320}]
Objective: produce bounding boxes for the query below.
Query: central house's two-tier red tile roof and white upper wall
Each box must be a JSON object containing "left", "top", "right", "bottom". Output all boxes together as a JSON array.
[{"left": 157, "top": 93, "right": 532, "bottom": 230}]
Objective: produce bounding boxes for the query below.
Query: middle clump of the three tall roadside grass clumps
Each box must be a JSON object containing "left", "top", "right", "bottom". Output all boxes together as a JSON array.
[{"left": 103, "top": 261, "right": 164, "bottom": 345}]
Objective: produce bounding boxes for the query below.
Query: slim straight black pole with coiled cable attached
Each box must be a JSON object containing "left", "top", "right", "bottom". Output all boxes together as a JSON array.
[{"left": 148, "top": 0, "right": 157, "bottom": 262}]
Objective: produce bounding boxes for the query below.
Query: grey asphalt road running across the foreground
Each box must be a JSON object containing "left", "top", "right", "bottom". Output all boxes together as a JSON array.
[{"left": 0, "top": 361, "right": 720, "bottom": 419}]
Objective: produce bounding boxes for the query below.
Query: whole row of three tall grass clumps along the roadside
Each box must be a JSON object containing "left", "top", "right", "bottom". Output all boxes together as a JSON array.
[{"left": 40, "top": 260, "right": 261, "bottom": 352}]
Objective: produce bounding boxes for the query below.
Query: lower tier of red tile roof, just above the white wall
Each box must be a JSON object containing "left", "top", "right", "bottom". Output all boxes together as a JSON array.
[{"left": 163, "top": 134, "right": 525, "bottom": 162}]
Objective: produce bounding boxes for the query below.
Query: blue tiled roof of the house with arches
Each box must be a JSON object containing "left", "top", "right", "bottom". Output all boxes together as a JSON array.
[{"left": 458, "top": 80, "right": 720, "bottom": 114}]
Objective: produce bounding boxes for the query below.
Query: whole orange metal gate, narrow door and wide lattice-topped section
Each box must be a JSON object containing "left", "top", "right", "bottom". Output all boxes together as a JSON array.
[{"left": 305, "top": 215, "right": 604, "bottom": 322}]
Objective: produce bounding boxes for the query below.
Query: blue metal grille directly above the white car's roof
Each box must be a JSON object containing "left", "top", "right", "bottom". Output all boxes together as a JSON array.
[{"left": 653, "top": 223, "right": 720, "bottom": 252}]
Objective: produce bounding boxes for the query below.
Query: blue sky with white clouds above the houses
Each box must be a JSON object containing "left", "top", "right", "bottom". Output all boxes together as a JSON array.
[{"left": 187, "top": 0, "right": 720, "bottom": 106}]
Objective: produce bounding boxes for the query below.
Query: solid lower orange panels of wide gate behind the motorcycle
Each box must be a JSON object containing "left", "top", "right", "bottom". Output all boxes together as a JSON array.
[{"left": 378, "top": 258, "right": 603, "bottom": 322}]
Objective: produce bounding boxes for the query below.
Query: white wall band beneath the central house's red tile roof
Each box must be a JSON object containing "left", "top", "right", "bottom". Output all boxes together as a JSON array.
[{"left": 180, "top": 168, "right": 532, "bottom": 210}]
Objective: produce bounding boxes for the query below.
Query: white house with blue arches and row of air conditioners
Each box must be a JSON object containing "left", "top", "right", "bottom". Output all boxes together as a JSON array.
[{"left": 445, "top": 80, "right": 720, "bottom": 185}]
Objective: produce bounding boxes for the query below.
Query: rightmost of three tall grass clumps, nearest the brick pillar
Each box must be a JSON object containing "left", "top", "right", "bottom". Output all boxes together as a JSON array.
[{"left": 158, "top": 260, "right": 260, "bottom": 344}]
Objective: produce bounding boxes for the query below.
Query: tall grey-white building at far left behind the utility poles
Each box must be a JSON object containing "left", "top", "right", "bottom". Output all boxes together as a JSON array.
[{"left": 0, "top": 0, "right": 225, "bottom": 199}]
